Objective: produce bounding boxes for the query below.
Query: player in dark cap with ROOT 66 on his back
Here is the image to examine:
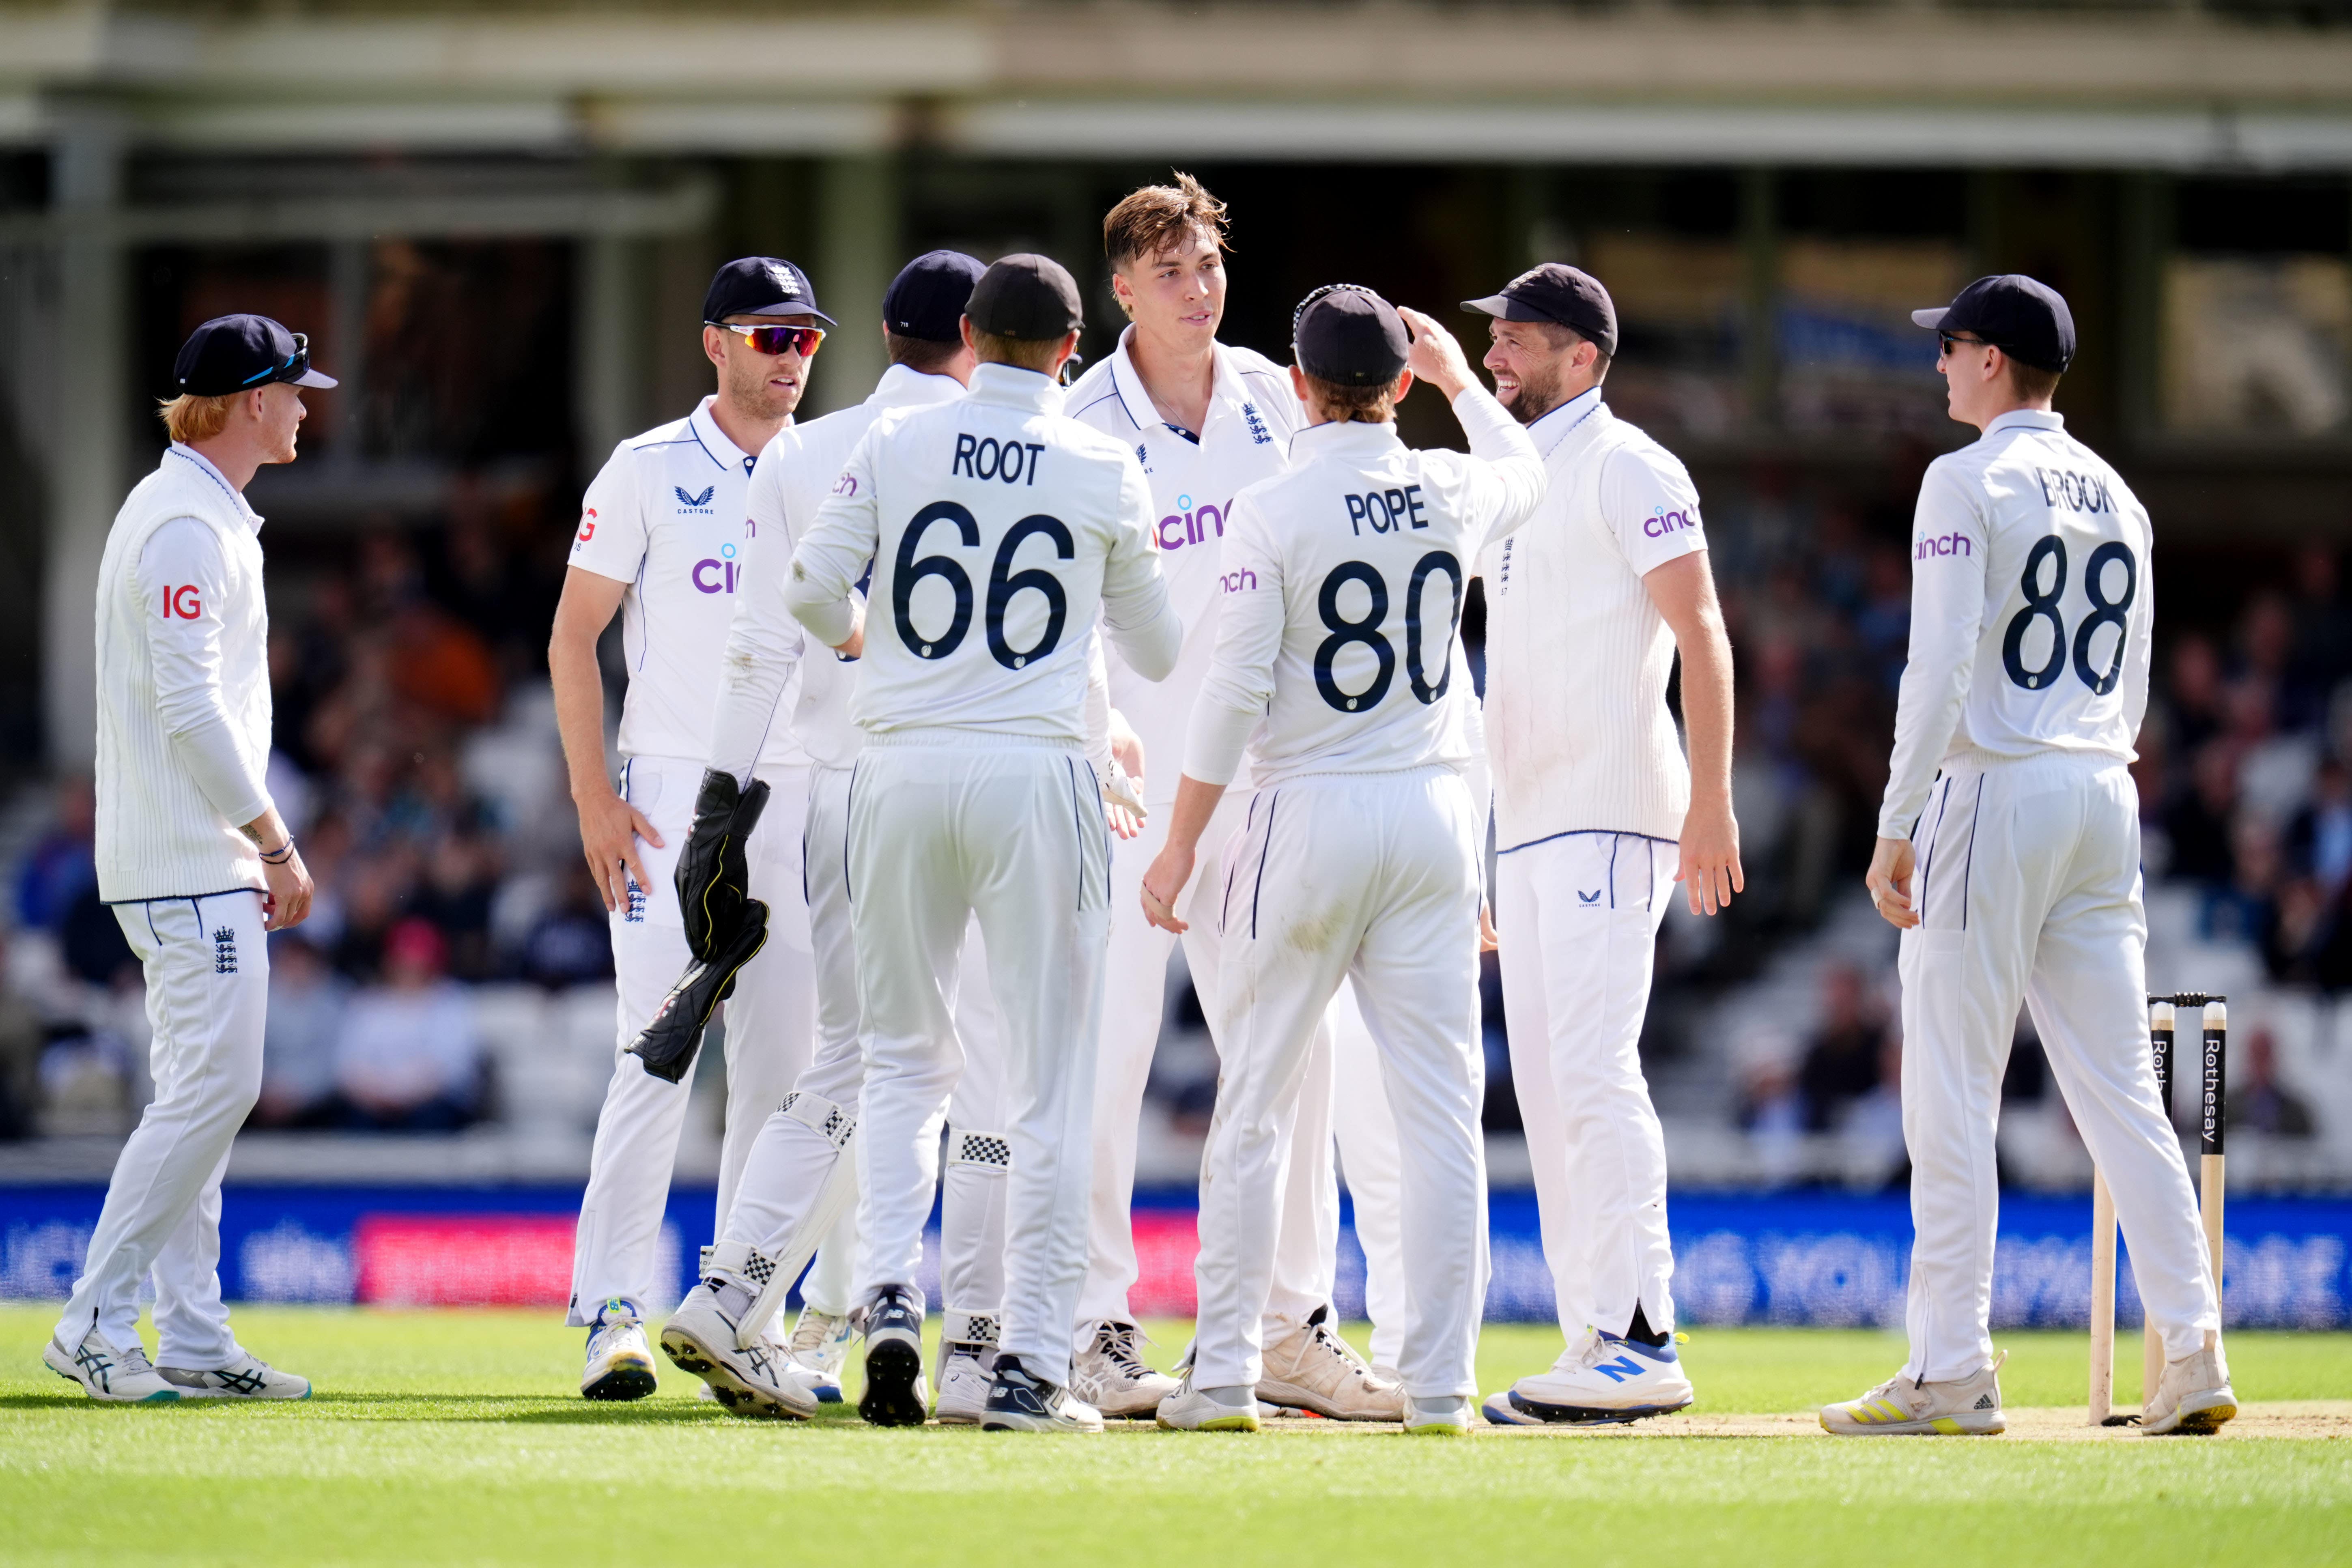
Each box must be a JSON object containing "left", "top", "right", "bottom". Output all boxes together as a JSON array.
[{"left": 788, "top": 256, "right": 1181, "bottom": 1432}]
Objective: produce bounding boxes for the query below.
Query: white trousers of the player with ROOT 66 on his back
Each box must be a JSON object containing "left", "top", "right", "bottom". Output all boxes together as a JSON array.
[{"left": 849, "top": 731, "right": 1110, "bottom": 1382}]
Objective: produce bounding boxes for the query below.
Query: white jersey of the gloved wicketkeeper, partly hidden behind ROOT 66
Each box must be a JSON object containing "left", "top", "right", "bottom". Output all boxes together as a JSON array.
[{"left": 710, "top": 364, "right": 964, "bottom": 783}]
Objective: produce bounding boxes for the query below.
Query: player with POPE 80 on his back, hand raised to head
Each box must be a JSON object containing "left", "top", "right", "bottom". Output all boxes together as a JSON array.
[{"left": 1143, "top": 284, "right": 1543, "bottom": 1432}]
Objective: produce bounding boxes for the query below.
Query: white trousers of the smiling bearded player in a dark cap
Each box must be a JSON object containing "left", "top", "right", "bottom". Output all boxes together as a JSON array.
[{"left": 1493, "top": 832, "right": 1682, "bottom": 1342}]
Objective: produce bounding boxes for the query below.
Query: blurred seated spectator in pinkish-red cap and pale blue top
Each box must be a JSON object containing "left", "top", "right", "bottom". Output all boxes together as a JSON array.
[{"left": 334, "top": 919, "right": 482, "bottom": 1133}]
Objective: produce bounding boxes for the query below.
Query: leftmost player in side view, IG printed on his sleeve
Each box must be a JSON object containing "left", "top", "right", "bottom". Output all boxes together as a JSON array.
[{"left": 40, "top": 315, "right": 334, "bottom": 1403}]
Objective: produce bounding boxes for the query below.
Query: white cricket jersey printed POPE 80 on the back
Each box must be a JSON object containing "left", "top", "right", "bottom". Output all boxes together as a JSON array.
[{"left": 1183, "top": 388, "right": 1543, "bottom": 787}]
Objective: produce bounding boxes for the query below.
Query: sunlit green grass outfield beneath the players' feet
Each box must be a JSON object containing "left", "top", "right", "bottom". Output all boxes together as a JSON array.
[{"left": 0, "top": 1307, "right": 2352, "bottom": 1568}]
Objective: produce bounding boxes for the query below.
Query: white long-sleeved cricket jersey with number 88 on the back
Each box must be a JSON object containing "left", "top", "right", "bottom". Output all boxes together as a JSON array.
[{"left": 1879, "top": 409, "right": 2157, "bottom": 839}]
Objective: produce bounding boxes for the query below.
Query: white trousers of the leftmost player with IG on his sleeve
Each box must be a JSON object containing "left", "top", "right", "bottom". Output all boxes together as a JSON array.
[{"left": 56, "top": 891, "right": 271, "bottom": 1368}]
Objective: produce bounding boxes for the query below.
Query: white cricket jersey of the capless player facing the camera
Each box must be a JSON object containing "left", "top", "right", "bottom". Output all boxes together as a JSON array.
[{"left": 1065, "top": 327, "right": 1305, "bottom": 807}]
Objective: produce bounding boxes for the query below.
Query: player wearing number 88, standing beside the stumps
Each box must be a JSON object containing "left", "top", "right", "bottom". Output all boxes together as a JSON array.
[{"left": 1820, "top": 273, "right": 2237, "bottom": 1437}]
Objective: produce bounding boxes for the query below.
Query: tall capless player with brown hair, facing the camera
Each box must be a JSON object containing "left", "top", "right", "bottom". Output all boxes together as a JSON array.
[{"left": 1068, "top": 174, "right": 1402, "bottom": 1420}]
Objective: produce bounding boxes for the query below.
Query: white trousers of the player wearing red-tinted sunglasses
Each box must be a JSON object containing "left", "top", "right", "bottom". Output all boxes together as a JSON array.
[{"left": 567, "top": 757, "right": 816, "bottom": 1328}]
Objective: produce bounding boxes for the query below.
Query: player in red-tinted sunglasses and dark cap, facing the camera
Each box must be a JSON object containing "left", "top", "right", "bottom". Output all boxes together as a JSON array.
[{"left": 548, "top": 256, "right": 833, "bottom": 1399}]
